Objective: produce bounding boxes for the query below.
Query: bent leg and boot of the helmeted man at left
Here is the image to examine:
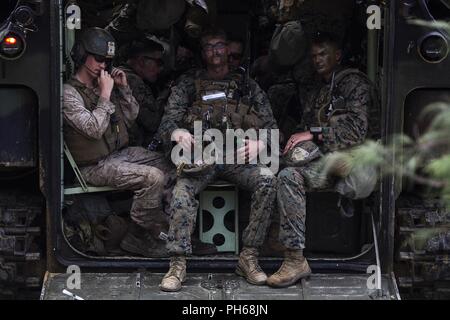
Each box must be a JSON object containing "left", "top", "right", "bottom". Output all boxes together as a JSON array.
[{"left": 82, "top": 148, "right": 166, "bottom": 257}]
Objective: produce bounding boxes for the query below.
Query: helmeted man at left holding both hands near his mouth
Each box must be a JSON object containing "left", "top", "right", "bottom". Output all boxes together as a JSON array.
[{"left": 63, "top": 28, "right": 172, "bottom": 256}]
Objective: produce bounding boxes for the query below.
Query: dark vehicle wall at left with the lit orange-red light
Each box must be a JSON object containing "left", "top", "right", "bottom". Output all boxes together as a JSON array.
[{"left": 0, "top": 0, "right": 55, "bottom": 299}]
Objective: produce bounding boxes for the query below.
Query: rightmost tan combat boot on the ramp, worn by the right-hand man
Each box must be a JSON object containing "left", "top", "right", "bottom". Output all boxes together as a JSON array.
[{"left": 267, "top": 250, "right": 311, "bottom": 288}]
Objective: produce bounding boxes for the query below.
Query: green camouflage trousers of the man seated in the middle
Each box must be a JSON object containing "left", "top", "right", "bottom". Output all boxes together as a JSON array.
[{"left": 167, "top": 164, "right": 277, "bottom": 255}]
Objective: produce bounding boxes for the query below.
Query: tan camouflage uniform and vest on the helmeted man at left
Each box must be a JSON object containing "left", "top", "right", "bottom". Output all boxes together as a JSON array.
[{"left": 63, "top": 78, "right": 173, "bottom": 230}]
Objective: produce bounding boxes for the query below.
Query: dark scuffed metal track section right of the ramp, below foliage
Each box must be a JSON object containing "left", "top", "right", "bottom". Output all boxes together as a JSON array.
[{"left": 396, "top": 197, "right": 450, "bottom": 299}]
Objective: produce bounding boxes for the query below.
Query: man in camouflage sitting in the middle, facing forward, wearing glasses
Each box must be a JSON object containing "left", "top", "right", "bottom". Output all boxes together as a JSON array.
[{"left": 160, "top": 31, "right": 277, "bottom": 291}]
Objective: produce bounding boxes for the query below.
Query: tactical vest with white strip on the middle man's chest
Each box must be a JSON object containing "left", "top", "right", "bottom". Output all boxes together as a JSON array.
[{"left": 183, "top": 74, "right": 262, "bottom": 132}]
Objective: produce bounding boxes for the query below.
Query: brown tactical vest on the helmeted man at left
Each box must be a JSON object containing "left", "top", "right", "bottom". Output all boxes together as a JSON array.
[{"left": 64, "top": 78, "right": 128, "bottom": 166}]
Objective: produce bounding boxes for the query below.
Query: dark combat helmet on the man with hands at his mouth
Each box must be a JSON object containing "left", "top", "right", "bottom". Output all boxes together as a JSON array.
[{"left": 70, "top": 28, "right": 116, "bottom": 66}]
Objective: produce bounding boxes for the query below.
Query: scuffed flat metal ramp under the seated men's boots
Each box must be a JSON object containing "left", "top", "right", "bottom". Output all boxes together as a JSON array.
[{"left": 41, "top": 272, "right": 400, "bottom": 300}]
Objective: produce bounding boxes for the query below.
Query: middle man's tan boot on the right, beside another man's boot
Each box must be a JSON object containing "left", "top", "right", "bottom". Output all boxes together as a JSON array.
[{"left": 236, "top": 247, "right": 267, "bottom": 285}]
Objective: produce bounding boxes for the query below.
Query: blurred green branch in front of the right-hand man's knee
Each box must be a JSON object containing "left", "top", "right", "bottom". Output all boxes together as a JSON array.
[{"left": 324, "top": 102, "right": 450, "bottom": 208}]
